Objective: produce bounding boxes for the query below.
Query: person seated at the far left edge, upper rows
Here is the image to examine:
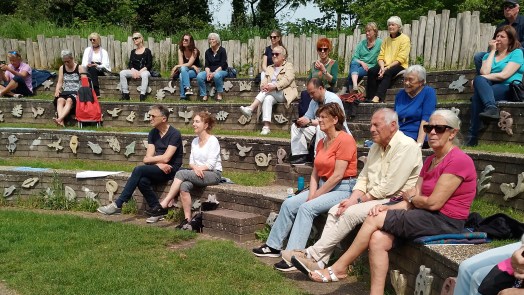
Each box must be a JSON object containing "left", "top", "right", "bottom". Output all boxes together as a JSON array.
[{"left": 0, "top": 51, "right": 33, "bottom": 97}]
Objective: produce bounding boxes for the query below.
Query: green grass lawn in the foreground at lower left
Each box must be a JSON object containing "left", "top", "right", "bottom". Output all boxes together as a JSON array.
[{"left": 0, "top": 209, "right": 301, "bottom": 295}]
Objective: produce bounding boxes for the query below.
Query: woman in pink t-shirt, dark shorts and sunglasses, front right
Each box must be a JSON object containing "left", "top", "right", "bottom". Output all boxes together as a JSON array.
[{"left": 292, "top": 110, "right": 477, "bottom": 295}]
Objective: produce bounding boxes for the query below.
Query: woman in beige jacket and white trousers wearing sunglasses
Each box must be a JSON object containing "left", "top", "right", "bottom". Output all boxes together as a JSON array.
[{"left": 240, "top": 46, "right": 298, "bottom": 135}]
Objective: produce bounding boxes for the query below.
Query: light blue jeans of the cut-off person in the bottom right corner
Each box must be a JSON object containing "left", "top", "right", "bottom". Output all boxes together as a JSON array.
[{"left": 453, "top": 242, "right": 522, "bottom": 295}]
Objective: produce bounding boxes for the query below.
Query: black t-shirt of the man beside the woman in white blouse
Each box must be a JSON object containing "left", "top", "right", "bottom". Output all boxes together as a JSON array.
[{"left": 147, "top": 126, "right": 184, "bottom": 172}]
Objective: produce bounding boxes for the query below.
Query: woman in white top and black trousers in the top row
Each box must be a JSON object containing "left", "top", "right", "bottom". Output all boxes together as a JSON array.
[{"left": 82, "top": 33, "right": 111, "bottom": 96}]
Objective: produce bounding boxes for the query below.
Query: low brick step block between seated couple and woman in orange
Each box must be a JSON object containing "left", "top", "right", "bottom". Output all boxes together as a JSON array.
[{"left": 202, "top": 209, "right": 266, "bottom": 242}]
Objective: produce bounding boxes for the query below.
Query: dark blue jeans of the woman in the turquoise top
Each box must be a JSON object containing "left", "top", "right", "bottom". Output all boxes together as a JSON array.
[{"left": 469, "top": 76, "right": 509, "bottom": 139}]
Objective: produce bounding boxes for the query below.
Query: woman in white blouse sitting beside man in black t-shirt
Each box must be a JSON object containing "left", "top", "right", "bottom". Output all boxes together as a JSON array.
[{"left": 160, "top": 112, "right": 222, "bottom": 228}]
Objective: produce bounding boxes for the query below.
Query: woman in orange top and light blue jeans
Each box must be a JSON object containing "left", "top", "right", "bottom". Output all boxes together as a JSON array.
[{"left": 253, "top": 103, "right": 357, "bottom": 271}]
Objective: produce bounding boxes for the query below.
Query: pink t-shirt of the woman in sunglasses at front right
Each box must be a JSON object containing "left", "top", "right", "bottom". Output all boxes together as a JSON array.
[{"left": 420, "top": 147, "right": 477, "bottom": 220}]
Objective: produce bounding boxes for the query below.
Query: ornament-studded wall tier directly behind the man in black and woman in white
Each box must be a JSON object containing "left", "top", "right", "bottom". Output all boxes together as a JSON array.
[{"left": 0, "top": 128, "right": 290, "bottom": 171}]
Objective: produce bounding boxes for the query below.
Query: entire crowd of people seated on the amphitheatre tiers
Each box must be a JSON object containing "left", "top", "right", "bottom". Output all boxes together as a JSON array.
[{"left": 4, "top": 11, "right": 524, "bottom": 294}]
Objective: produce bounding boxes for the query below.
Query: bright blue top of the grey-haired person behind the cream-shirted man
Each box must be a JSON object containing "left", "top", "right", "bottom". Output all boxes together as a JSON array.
[{"left": 395, "top": 86, "right": 437, "bottom": 141}]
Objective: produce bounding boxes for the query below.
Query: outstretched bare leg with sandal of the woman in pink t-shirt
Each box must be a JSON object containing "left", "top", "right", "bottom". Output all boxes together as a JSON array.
[{"left": 310, "top": 211, "right": 387, "bottom": 282}]
